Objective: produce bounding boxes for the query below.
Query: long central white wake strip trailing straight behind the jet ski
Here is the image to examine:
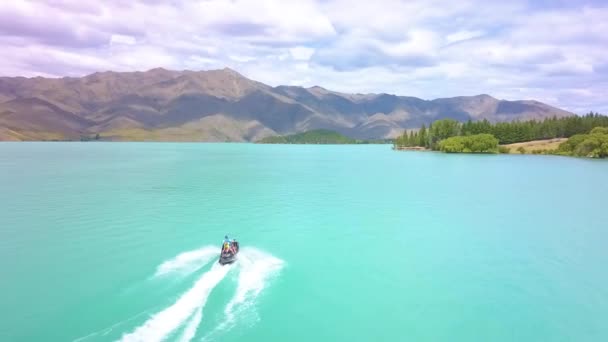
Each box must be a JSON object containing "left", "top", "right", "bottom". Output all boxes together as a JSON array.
[{"left": 121, "top": 264, "right": 230, "bottom": 341}]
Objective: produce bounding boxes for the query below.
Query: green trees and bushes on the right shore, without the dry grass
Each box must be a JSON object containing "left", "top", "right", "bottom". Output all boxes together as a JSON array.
[{"left": 394, "top": 112, "right": 608, "bottom": 155}]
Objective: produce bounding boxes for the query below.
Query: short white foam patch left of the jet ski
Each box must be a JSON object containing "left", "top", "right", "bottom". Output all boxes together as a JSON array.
[{"left": 154, "top": 246, "right": 219, "bottom": 277}]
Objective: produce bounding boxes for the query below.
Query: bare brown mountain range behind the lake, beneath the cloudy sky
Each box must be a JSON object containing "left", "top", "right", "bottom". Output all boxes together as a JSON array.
[{"left": 0, "top": 68, "right": 574, "bottom": 141}]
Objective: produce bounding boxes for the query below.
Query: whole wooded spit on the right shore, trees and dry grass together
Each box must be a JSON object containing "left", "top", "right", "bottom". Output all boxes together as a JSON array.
[{"left": 393, "top": 113, "right": 608, "bottom": 158}]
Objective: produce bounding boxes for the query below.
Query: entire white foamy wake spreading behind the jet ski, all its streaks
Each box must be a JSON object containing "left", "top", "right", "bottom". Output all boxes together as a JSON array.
[{"left": 114, "top": 246, "right": 284, "bottom": 341}]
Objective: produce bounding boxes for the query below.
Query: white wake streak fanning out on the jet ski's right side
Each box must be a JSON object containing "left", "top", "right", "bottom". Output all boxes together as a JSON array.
[{"left": 204, "top": 247, "right": 285, "bottom": 340}]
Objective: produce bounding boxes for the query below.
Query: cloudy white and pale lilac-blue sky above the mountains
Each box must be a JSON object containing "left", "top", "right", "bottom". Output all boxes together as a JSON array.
[{"left": 0, "top": 0, "right": 608, "bottom": 113}]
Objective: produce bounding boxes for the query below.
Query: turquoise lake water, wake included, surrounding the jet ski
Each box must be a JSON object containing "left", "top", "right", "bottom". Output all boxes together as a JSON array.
[{"left": 0, "top": 143, "right": 608, "bottom": 341}]
